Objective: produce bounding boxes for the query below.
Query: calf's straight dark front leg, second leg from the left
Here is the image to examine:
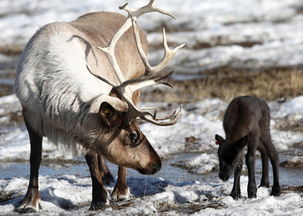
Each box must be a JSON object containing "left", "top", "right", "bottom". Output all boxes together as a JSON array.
[{"left": 246, "top": 134, "right": 259, "bottom": 198}]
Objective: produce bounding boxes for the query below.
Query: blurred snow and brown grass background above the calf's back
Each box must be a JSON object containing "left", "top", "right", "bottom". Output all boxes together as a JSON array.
[{"left": 0, "top": 0, "right": 303, "bottom": 102}]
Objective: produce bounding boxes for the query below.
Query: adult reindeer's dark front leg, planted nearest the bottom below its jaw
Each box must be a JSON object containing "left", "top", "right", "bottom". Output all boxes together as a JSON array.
[{"left": 85, "top": 151, "right": 109, "bottom": 210}]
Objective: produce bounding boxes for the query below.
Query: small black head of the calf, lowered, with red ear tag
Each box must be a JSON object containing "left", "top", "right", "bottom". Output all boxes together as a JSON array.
[{"left": 215, "top": 134, "right": 246, "bottom": 181}]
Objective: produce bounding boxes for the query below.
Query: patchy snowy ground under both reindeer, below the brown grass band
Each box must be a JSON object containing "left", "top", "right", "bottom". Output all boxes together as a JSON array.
[{"left": 0, "top": 96, "right": 303, "bottom": 215}]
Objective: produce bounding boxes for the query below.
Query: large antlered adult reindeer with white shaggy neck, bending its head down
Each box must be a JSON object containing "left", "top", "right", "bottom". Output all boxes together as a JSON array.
[{"left": 15, "top": 0, "right": 184, "bottom": 211}]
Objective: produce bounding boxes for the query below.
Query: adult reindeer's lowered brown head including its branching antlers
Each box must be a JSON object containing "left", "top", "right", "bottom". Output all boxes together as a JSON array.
[{"left": 87, "top": 0, "right": 184, "bottom": 174}]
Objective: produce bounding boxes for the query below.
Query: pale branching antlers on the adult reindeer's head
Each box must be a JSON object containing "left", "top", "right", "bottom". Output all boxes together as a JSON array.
[{"left": 88, "top": 0, "right": 185, "bottom": 126}]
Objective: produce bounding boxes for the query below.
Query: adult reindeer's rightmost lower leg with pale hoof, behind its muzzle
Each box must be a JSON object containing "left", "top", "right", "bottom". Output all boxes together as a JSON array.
[{"left": 112, "top": 166, "right": 130, "bottom": 200}]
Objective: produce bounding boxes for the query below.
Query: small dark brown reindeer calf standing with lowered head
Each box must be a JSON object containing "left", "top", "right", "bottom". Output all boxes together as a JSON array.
[{"left": 215, "top": 96, "right": 281, "bottom": 199}]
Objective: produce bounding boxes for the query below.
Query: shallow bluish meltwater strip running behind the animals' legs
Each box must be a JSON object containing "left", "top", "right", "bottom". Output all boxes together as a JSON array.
[{"left": 0, "top": 152, "right": 303, "bottom": 194}]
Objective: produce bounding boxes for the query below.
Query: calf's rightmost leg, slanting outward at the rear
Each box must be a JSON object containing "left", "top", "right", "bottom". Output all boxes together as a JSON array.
[{"left": 265, "top": 138, "right": 281, "bottom": 196}]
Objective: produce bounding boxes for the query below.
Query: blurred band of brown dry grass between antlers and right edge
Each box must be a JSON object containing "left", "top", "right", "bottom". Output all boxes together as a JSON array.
[{"left": 142, "top": 68, "right": 303, "bottom": 103}]
